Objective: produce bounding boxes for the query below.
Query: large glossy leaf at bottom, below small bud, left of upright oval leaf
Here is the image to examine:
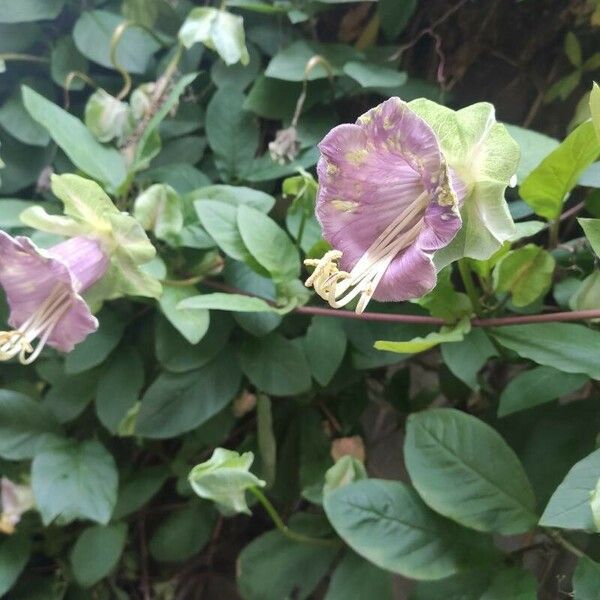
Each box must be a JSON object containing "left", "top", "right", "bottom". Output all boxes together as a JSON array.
[{"left": 324, "top": 479, "right": 492, "bottom": 580}]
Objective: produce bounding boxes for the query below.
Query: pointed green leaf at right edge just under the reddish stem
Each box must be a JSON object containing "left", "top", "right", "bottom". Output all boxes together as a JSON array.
[{"left": 492, "top": 323, "right": 600, "bottom": 379}]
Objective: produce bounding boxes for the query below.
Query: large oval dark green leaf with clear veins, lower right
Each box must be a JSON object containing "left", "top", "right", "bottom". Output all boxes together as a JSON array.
[{"left": 404, "top": 409, "right": 537, "bottom": 535}]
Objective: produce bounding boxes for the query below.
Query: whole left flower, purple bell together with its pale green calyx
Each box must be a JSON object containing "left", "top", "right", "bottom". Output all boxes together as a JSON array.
[{"left": 0, "top": 175, "right": 162, "bottom": 364}]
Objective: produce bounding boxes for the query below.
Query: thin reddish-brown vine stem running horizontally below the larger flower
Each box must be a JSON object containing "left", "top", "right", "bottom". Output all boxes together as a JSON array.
[{"left": 198, "top": 279, "right": 600, "bottom": 327}]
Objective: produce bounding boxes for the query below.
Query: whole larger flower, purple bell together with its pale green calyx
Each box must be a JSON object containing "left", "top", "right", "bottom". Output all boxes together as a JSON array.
[{"left": 306, "top": 98, "right": 518, "bottom": 313}]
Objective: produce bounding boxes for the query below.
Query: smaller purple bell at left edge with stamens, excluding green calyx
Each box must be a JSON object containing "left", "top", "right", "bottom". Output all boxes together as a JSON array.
[{"left": 0, "top": 231, "right": 109, "bottom": 364}]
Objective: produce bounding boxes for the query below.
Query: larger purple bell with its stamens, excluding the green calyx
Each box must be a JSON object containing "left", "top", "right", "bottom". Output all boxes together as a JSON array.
[{"left": 306, "top": 98, "right": 466, "bottom": 313}]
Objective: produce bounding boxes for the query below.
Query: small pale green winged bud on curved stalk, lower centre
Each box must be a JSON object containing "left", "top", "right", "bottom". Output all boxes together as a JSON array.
[{"left": 188, "top": 448, "right": 266, "bottom": 515}]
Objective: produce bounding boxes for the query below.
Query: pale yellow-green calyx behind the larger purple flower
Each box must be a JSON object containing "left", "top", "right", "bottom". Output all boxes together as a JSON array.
[{"left": 408, "top": 98, "right": 519, "bottom": 269}]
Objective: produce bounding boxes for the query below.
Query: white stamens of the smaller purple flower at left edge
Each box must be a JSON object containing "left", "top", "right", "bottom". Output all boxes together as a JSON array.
[{"left": 0, "top": 285, "right": 71, "bottom": 365}]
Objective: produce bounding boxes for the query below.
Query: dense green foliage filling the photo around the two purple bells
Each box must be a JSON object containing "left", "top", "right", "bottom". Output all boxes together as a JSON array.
[{"left": 0, "top": 0, "right": 600, "bottom": 600}]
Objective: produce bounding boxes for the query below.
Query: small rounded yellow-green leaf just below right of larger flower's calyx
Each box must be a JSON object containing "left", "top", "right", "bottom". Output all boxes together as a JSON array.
[{"left": 493, "top": 244, "right": 556, "bottom": 307}]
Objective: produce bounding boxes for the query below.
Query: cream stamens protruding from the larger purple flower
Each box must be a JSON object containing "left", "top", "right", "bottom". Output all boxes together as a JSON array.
[{"left": 304, "top": 192, "right": 428, "bottom": 314}]
